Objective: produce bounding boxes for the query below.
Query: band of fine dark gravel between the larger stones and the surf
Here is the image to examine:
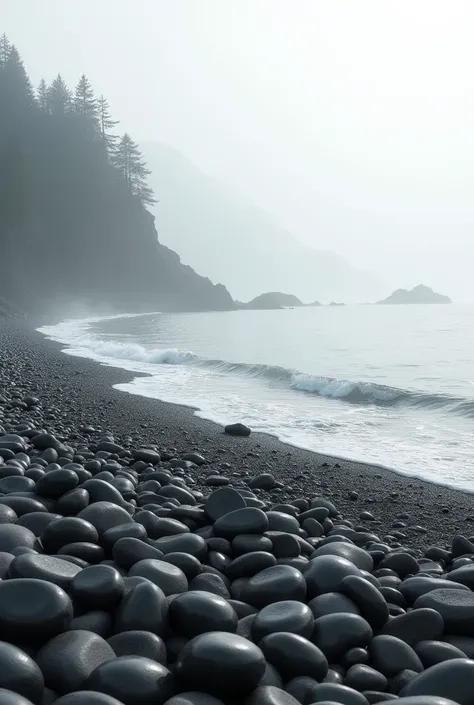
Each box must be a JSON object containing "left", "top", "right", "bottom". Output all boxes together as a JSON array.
[{"left": 0, "top": 320, "right": 474, "bottom": 549}]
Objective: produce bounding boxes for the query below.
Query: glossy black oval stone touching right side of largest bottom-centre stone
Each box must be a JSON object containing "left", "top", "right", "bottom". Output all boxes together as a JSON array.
[{"left": 259, "top": 632, "right": 328, "bottom": 681}]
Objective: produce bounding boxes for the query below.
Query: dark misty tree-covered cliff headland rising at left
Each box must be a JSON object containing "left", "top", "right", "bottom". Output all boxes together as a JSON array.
[{"left": 0, "top": 38, "right": 234, "bottom": 313}]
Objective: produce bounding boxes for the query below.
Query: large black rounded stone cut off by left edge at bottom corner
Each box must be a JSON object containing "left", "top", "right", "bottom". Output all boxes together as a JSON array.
[{"left": 0, "top": 641, "right": 44, "bottom": 704}]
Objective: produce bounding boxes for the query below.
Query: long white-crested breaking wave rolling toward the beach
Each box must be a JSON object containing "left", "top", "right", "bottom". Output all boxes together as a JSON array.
[{"left": 64, "top": 341, "right": 474, "bottom": 418}]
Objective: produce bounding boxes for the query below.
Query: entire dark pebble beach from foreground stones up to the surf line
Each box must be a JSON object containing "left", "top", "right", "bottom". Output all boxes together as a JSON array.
[{"left": 0, "top": 321, "right": 474, "bottom": 705}]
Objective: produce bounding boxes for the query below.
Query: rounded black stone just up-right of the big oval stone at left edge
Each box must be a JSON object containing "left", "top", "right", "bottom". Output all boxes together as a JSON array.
[{"left": 70, "top": 565, "right": 125, "bottom": 611}]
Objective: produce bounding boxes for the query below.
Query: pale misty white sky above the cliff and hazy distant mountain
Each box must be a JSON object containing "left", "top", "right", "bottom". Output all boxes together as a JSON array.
[{"left": 0, "top": 0, "right": 474, "bottom": 301}]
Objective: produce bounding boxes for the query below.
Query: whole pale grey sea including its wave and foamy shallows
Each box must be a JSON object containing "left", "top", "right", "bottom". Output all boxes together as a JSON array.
[{"left": 39, "top": 305, "right": 474, "bottom": 491}]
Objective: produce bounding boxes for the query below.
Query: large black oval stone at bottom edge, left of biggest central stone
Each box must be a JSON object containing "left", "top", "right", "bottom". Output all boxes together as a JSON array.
[{"left": 86, "top": 656, "right": 173, "bottom": 705}]
